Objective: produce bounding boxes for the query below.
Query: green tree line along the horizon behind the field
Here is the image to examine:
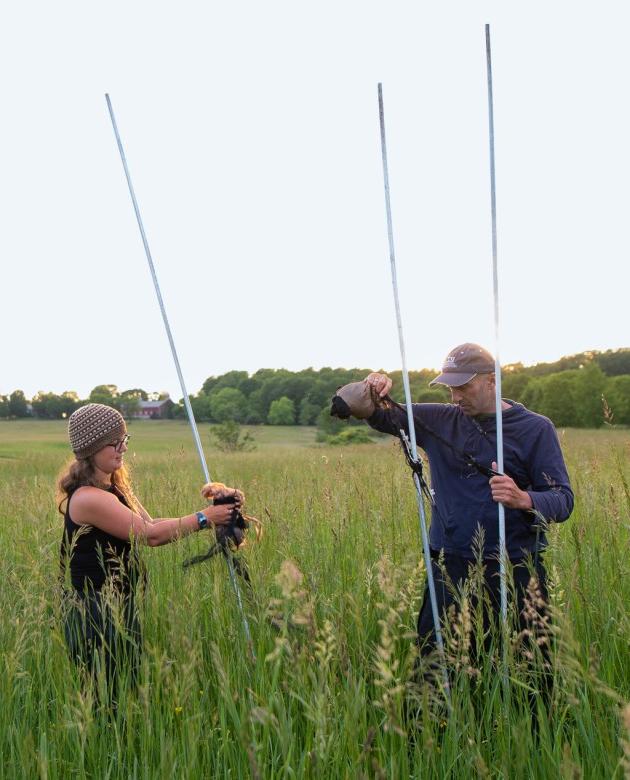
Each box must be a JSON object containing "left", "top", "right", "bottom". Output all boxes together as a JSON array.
[{"left": 0, "top": 349, "right": 630, "bottom": 431}]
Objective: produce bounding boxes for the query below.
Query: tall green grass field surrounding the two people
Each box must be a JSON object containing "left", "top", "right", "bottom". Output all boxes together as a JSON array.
[{"left": 0, "top": 422, "right": 630, "bottom": 778}]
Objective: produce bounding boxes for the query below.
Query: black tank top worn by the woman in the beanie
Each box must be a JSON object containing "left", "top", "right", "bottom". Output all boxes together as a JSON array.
[{"left": 61, "top": 485, "right": 143, "bottom": 594}]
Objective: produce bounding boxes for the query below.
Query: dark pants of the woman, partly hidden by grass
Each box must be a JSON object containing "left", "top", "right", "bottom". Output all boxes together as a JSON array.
[{"left": 64, "top": 591, "right": 142, "bottom": 705}]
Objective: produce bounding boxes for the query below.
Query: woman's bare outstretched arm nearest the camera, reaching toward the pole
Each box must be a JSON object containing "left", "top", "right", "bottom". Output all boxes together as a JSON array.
[{"left": 72, "top": 487, "right": 233, "bottom": 547}]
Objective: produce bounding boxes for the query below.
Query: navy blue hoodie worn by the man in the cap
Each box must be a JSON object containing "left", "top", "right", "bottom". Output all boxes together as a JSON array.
[{"left": 368, "top": 399, "right": 573, "bottom": 560}]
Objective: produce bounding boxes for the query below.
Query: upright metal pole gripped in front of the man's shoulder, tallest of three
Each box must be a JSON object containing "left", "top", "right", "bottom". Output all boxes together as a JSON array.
[{"left": 486, "top": 24, "right": 507, "bottom": 627}]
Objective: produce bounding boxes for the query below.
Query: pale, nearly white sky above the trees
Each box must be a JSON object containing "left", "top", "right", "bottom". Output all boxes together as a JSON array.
[{"left": 0, "top": 0, "right": 630, "bottom": 398}]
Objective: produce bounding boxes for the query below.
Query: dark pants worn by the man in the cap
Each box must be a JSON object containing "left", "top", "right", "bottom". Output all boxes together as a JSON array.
[{"left": 418, "top": 554, "right": 552, "bottom": 699}]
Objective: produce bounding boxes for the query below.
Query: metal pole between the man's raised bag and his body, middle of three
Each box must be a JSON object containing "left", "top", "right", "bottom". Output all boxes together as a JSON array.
[{"left": 378, "top": 83, "right": 446, "bottom": 676}]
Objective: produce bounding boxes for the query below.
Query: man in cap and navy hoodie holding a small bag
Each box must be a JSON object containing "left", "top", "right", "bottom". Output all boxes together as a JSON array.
[{"left": 366, "top": 343, "right": 573, "bottom": 655}]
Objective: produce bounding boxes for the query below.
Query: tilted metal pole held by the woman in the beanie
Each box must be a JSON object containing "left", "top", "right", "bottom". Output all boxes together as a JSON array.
[{"left": 105, "top": 94, "right": 255, "bottom": 659}]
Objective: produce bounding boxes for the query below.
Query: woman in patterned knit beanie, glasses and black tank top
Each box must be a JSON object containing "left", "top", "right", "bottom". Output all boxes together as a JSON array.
[{"left": 59, "top": 404, "right": 243, "bottom": 701}]
